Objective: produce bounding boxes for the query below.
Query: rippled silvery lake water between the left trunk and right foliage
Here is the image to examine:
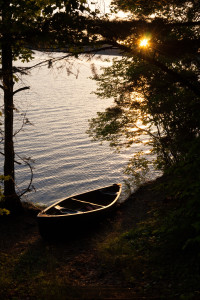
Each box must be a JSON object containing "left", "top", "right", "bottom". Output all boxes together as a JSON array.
[{"left": 0, "top": 52, "right": 156, "bottom": 204}]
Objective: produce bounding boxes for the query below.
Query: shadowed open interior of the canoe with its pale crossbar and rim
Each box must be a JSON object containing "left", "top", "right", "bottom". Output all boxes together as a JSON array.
[{"left": 41, "top": 184, "right": 121, "bottom": 216}]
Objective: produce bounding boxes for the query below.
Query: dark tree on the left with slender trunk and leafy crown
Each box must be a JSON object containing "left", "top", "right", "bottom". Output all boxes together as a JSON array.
[{"left": 0, "top": 0, "right": 91, "bottom": 211}]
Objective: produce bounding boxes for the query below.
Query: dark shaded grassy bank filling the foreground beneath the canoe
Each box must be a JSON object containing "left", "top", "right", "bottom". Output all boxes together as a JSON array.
[{"left": 0, "top": 180, "right": 200, "bottom": 300}]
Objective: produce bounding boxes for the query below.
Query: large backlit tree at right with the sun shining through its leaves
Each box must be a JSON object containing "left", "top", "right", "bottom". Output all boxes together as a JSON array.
[{"left": 89, "top": 0, "right": 200, "bottom": 183}]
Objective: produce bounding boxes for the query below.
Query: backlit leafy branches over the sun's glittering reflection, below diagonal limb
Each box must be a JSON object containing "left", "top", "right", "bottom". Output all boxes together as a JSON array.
[{"left": 89, "top": 49, "right": 200, "bottom": 168}]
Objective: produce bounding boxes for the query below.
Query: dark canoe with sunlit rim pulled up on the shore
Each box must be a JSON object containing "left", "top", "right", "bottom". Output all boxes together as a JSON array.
[{"left": 37, "top": 184, "right": 121, "bottom": 237}]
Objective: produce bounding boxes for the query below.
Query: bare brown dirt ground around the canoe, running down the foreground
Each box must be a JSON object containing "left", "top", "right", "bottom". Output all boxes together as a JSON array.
[{"left": 0, "top": 179, "right": 166, "bottom": 299}]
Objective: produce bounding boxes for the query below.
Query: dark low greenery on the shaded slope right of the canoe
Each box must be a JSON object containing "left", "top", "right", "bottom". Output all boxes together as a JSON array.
[{"left": 99, "top": 200, "right": 200, "bottom": 299}]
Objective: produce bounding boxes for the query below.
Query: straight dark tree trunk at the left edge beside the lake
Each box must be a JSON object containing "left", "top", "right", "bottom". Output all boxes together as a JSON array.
[{"left": 2, "top": 34, "right": 22, "bottom": 212}]
